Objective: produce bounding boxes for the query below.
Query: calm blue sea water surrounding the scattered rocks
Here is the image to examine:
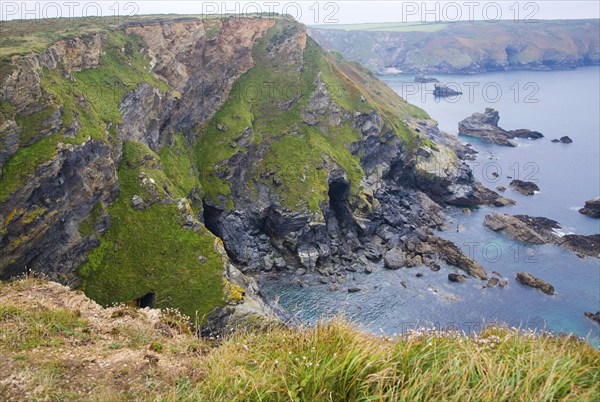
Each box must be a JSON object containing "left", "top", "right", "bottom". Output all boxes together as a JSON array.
[{"left": 261, "top": 67, "right": 600, "bottom": 344}]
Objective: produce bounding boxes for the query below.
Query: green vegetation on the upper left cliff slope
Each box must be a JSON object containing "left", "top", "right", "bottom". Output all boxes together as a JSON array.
[{"left": 0, "top": 30, "right": 166, "bottom": 202}]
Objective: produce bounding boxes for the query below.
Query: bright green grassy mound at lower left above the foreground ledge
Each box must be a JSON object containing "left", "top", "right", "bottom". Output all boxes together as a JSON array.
[{"left": 79, "top": 142, "right": 225, "bottom": 320}]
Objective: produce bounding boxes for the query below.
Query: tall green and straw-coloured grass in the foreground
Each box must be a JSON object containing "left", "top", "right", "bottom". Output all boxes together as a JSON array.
[{"left": 185, "top": 321, "right": 600, "bottom": 401}]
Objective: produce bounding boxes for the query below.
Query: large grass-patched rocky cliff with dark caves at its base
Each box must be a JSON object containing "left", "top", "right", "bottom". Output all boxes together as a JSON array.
[{"left": 0, "top": 18, "right": 507, "bottom": 322}]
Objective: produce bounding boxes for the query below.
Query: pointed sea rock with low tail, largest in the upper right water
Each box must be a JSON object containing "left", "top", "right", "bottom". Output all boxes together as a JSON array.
[{"left": 458, "top": 108, "right": 544, "bottom": 147}]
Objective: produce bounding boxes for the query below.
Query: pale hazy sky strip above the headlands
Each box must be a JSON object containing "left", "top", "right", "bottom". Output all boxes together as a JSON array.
[{"left": 0, "top": 0, "right": 600, "bottom": 24}]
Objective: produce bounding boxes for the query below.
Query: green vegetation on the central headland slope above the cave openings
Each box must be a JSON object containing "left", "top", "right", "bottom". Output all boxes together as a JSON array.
[{"left": 195, "top": 20, "right": 427, "bottom": 212}]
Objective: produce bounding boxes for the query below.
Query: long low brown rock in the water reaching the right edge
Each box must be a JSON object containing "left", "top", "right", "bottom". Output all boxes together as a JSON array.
[{"left": 483, "top": 212, "right": 600, "bottom": 258}]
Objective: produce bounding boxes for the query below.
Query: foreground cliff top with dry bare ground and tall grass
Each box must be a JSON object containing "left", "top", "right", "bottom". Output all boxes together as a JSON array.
[{"left": 0, "top": 279, "right": 600, "bottom": 401}]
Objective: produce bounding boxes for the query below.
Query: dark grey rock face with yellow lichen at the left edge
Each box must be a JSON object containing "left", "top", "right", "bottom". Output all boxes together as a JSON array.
[{"left": 0, "top": 141, "right": 119, "bottom": 284}]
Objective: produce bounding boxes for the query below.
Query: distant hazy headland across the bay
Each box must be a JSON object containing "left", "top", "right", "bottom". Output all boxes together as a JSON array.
[{"left": 310, "top": 20, "right": 600, "bottom": 73}]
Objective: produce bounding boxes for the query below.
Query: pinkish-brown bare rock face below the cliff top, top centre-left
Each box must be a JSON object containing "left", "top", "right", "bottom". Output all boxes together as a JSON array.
[{"left": 124, "top": 18, "right": 274, "bottom": 138}]
